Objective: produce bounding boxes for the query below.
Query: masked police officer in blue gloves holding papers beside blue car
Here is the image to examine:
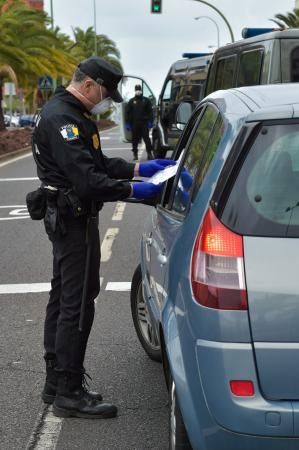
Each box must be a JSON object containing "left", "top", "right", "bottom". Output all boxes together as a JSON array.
[{"left": 33, "top": 56, "right": 177, "bottom": 418}]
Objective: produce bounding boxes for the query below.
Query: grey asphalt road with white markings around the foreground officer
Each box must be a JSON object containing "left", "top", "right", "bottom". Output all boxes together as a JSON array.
[{"left": 0, "top": 129, "right": 168, "bottom": 450}]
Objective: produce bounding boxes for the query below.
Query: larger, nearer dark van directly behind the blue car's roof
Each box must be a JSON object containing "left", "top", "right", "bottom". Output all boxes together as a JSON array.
[{"left": 203, "top": 28, "right": 299, "bottom": 97}]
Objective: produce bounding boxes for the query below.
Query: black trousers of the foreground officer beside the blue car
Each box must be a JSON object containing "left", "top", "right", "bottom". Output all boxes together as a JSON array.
[{"left": 44, "top": 216, "right": 101, "bottom": 373}]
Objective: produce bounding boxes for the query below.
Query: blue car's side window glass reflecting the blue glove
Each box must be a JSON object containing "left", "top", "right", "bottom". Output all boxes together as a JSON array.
[{"left": 172, "top": 105, "right": 218, "bottom": 214}]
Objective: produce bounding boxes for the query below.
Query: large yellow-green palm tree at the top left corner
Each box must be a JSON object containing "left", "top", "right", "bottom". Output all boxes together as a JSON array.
[{"left": 0, "top": 0, "right": 76, "bottom": 130}]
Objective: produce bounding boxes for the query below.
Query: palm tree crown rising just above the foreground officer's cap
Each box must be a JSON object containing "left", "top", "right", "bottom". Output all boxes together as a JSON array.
[{"left": 73, "top": 27, "right": 122, "bottom": 69}]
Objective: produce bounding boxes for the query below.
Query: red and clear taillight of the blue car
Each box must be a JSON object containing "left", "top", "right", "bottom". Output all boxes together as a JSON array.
[{"left": 191, "top": 208, "right": 248, "bottom": 310}]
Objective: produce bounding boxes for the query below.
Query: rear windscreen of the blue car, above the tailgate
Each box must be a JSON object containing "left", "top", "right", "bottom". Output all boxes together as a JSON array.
[{"left": 221, "top": 123, "right": 299, "bottom": 237}]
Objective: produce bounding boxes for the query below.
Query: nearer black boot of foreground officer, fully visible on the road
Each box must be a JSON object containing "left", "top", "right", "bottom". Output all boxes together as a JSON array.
[{"left": 53, "top": 372, "right": 117, "bottom": 419}]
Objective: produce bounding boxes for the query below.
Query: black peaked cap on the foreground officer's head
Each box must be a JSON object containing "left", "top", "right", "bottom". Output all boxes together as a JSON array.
[{"left": 78, "top": 56, "right": 123, "bottom": 103}]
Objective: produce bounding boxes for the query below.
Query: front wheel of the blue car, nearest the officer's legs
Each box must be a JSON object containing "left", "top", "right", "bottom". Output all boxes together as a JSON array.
[{"left": 131, "top": 265, "right": 162, "bottom": 361}]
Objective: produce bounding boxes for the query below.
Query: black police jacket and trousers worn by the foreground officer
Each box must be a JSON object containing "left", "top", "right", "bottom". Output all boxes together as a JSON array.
[{"left": 33, "top": 88, "right": 134, "bottom": 373}]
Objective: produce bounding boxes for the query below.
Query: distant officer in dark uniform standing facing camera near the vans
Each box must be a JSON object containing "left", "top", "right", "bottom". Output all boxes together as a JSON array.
[{"left": 126, "top": 84, "right": 153, "bottom": 160}]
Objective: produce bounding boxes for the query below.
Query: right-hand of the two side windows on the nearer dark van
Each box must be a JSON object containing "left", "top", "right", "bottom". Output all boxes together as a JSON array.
[{"left": 237, "top": 49, "right": 264, "bottom": 86}]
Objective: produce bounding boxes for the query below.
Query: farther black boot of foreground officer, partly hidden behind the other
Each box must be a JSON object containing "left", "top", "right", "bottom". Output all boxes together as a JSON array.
[{"left": 42, "top": 359, "right": 103, "bottom": 405}]
